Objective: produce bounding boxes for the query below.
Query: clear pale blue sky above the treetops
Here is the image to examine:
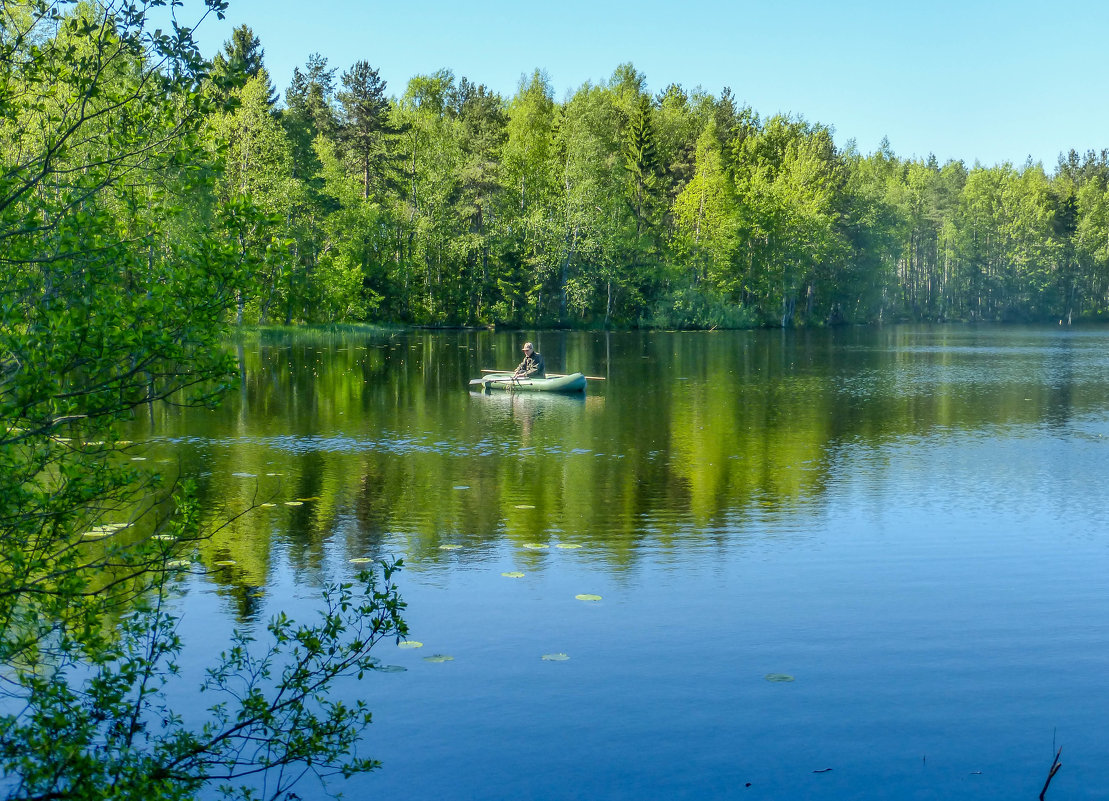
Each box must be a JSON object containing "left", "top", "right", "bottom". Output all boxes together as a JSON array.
[{"left": 186, "top": 0, "right": 1109, "bottom": 172}]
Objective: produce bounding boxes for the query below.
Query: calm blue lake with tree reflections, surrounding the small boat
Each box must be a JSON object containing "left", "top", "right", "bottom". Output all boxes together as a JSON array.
[{"left": 133, "top": 326, "right": 1109, "bottom": 801}]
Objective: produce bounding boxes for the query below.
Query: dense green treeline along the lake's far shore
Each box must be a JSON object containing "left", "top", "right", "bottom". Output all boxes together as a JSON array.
[{"left": 210, "top": 27, "right": 1109, "bottom": 327}]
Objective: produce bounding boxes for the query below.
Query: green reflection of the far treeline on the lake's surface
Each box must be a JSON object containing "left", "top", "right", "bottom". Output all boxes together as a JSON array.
[{"left": 123, "top": 327, "right": 1109, "bottom": 616}]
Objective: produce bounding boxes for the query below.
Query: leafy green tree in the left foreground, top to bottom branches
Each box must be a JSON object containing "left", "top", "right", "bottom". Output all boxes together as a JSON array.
[{"left": 0, "top": 1, "right": 405, "bottom": 799}]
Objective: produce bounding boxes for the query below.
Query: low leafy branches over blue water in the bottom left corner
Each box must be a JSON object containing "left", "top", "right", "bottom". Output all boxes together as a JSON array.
[{"left": 0, "top": 536, "right": 407, "bottom": 801}]
